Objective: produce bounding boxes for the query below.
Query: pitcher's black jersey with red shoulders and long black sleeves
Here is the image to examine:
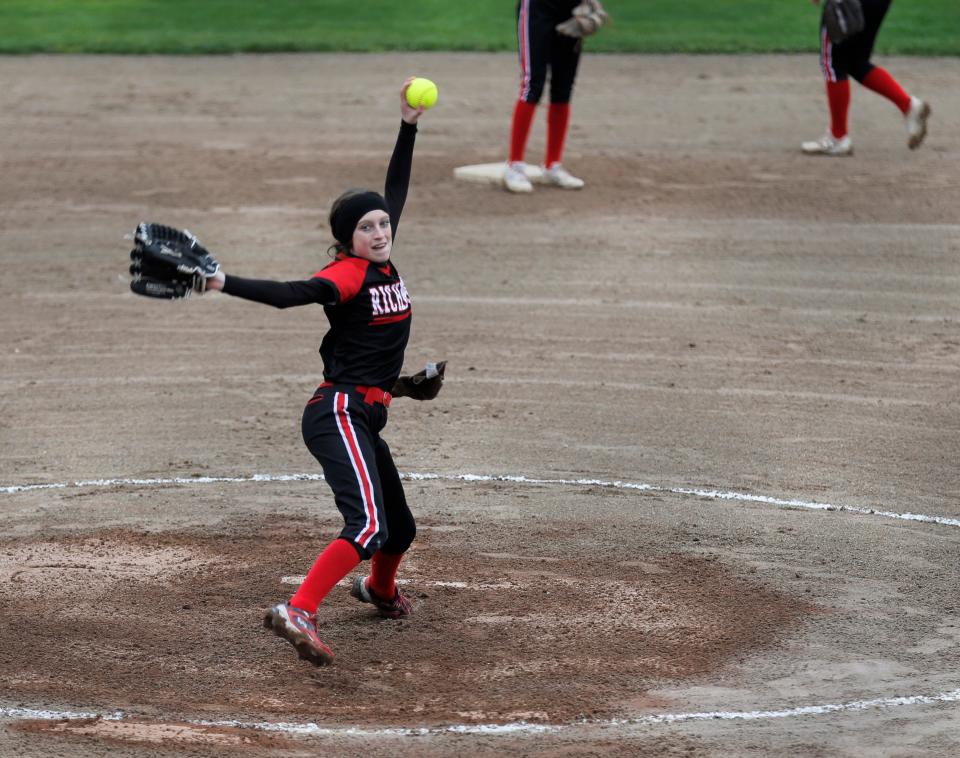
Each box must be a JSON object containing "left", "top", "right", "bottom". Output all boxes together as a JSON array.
[{"left": 223, "top": 122, "right": 417, "bottom": 391}]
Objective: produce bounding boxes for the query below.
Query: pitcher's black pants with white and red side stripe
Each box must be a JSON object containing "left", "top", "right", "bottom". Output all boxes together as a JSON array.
[{"left": 301, "top": 385, "right": 417, "bottom": 559}]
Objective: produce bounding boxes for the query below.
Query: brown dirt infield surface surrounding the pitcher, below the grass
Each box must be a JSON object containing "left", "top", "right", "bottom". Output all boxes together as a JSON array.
[{"left": 0, "top": 55, "right": 960, "bottom": 757}]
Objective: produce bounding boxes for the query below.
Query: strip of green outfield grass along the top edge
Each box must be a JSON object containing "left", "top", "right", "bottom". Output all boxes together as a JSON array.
[{"left": 0, "top": 0, "right": 960, "bottom": 55}]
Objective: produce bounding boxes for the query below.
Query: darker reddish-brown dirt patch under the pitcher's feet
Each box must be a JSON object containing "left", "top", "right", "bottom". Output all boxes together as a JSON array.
[{"left": 0, "top": 512, "right": 811, "bottom": 725}]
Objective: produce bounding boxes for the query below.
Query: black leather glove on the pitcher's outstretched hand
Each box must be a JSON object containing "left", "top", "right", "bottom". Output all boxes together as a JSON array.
[{"left": 130, "top": 223, "right": 220, "bottom": 300}]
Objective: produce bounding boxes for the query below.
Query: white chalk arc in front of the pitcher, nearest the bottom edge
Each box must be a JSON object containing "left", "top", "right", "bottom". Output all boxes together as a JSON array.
[{"left": 0, "top": 689, "right": 960, "bottom": 737}]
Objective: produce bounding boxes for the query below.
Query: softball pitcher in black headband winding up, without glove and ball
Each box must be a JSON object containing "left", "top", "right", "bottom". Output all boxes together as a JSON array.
[{"left": 207, "top": 78, "right": 436, "bottom": 666}]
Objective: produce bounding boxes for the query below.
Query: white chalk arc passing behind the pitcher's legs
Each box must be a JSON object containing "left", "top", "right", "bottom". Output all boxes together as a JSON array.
[{"left": 0, "top": 472, "right": 960, "bottom": 526}]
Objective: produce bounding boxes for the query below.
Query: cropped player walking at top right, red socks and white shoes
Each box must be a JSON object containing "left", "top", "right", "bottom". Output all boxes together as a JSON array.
[{"left": 801, "top": 0, "right": 930, "bottom": 156}]
